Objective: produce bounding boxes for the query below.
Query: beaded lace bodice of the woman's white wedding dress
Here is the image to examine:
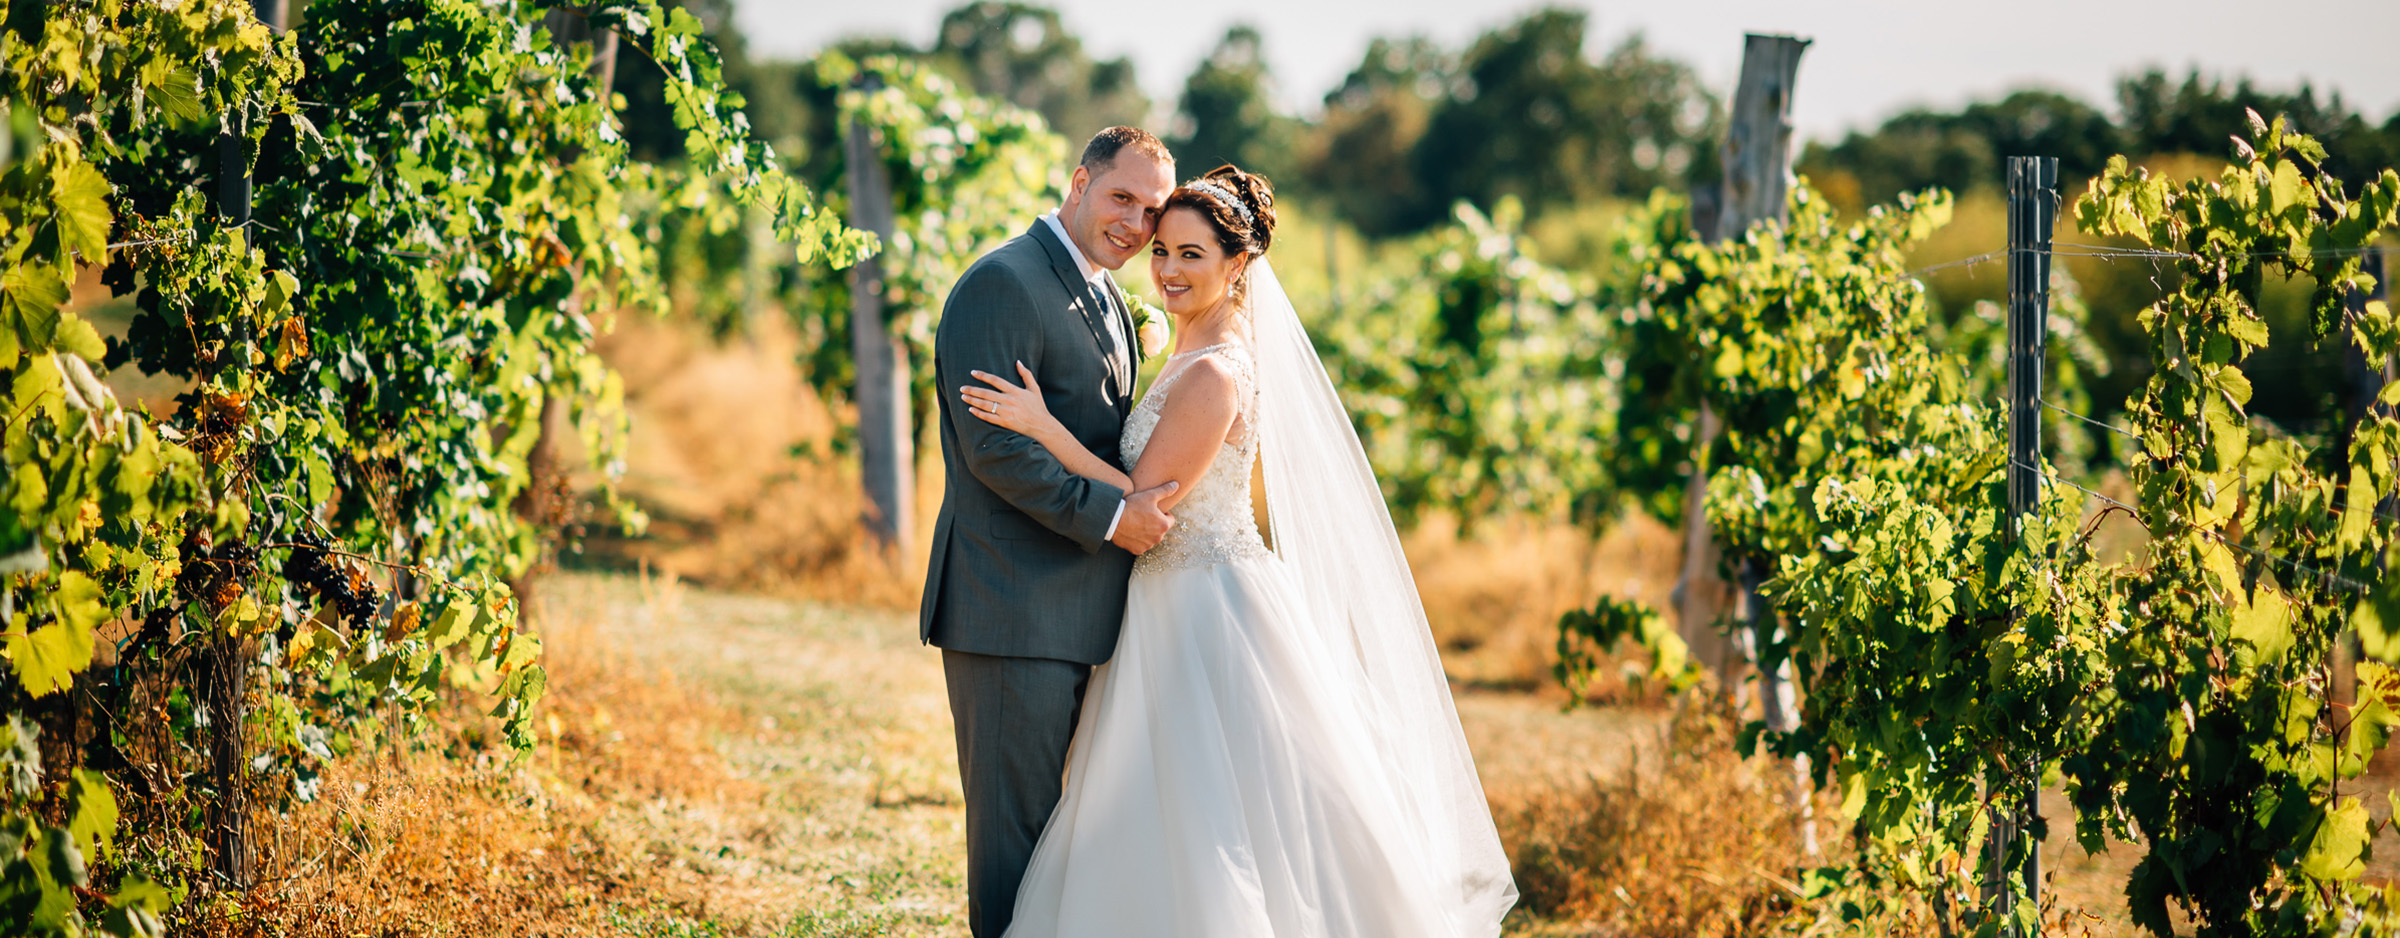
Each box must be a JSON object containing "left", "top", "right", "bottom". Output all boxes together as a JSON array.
[{"left": 1121, "top": 343, "right": 1267, "bottom": 576}]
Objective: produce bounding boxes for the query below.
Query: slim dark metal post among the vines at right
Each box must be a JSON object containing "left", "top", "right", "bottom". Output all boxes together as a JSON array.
[{"left": 1985, "top": 156, "right": 2059, "bottom": 928}]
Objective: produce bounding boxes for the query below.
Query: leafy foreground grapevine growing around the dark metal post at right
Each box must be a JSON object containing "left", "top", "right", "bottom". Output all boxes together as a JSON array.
[{"left": 1560, "top": 118, "right": 2400, "bottom": 936}]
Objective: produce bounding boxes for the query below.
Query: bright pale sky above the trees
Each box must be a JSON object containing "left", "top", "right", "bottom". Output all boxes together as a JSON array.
[{"left": 734, "top": 0, "right": 2400, "bottom": 139}]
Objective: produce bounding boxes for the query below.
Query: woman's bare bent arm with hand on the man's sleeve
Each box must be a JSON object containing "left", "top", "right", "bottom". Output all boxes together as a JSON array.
[{"left": 960, "top": 357, "right": 1241, "bottom": 511}]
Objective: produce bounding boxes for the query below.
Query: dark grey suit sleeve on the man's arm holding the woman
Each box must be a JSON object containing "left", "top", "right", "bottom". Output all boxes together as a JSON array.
[{"left": 934, "top": 264, "right": 1126, "bottom": 554}]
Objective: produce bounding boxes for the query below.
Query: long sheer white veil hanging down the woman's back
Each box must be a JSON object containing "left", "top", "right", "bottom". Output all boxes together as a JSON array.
[{"left": 1250, "top": 259, "right": 1517, "bottom": 933}]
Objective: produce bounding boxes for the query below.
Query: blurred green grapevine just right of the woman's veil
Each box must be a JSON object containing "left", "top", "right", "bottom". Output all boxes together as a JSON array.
[{"left": 1308, "top": 202, "right": 1630, "bottom": 523}]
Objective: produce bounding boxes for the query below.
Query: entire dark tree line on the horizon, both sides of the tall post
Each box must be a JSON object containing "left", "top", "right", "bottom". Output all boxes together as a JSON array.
[{"left": 600, "top": 0, "right": 2400, "bottom": 237}]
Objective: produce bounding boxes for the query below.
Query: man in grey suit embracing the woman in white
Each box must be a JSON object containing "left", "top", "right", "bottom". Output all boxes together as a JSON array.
[{"left": 919, "top": 127, "right": 1176, "bottom": 938}]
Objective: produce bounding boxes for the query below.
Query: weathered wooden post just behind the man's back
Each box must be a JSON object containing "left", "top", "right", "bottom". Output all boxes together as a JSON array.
[{"left": 847, "top": 72, "right": 917, "bottom": 559}]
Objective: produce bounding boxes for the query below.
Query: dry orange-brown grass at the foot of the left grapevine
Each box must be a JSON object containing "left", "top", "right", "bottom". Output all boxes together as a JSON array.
[{"left": 197, "top": 581, "right": 758, "bottom": 936}]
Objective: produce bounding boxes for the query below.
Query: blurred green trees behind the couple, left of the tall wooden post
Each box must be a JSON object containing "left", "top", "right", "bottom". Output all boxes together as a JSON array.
[{"left": 617, "top": 0, "right": 1723, "bottom": 235}]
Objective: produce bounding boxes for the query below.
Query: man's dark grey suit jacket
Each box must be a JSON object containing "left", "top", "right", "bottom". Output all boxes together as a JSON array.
[{"left": 919, "top": 221, "right": 1135, "bottom": 665}]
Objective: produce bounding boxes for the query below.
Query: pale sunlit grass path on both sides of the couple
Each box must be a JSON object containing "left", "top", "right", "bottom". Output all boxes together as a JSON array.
[{"left": 547, "top": 573, "right": 1656, "bottom": 936}]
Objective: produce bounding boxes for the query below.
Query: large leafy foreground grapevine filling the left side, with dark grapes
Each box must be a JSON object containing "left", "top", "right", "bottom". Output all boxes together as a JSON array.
[{"left": 0, "top": 0, "right": 874, "bottom": 936}]
